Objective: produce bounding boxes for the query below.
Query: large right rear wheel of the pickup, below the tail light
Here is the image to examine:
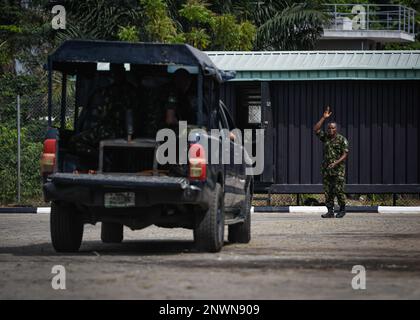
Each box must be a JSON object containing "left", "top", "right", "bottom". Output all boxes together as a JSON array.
[{"left": 194, "top": 183, "right": 225, "bottom": 252}]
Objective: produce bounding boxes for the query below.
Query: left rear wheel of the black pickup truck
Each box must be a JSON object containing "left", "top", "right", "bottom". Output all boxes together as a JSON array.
[{"left": 50, "top": 201, "right": 83, "bottom": 252}]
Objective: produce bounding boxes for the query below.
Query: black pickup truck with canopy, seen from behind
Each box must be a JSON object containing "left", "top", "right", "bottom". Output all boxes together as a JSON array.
[{"left": 41, "top": 40, "right": 253, "bottom": 252}]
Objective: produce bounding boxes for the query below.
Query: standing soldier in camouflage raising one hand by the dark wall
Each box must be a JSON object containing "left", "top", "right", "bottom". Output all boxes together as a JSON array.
[{"left": 314, "top": 107, "right": 349, "bottom": 218}]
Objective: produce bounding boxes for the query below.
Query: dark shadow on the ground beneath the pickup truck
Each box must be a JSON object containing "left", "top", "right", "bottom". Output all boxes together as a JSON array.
[{"left": 0, "top": 239, "right": 230, "bottom": 260}]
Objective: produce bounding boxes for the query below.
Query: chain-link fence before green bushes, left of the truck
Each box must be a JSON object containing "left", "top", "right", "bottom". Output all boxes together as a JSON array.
[{"left": 0, "top": 79, "right": 74, "bottom": 206}]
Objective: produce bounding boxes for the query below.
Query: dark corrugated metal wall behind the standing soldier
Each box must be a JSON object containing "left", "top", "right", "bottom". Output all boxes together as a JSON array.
[{"left": 221, "top": 80, "right": 420, "bottom": 189}]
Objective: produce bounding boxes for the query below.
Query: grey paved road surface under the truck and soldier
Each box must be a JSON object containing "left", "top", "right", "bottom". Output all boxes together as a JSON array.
[{"left": 0, "top": 213, "right": 420, "bottom": 299}]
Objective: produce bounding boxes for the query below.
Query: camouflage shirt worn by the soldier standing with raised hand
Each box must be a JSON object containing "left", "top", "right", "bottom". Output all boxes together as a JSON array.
[{"left": 317, "top": 130, "right": 349, "bottom": 176}]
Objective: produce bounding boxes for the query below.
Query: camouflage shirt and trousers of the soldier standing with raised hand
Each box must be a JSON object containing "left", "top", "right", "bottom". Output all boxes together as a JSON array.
[{"left": 317, "top": 130, "right": 349, "bottom": 209}]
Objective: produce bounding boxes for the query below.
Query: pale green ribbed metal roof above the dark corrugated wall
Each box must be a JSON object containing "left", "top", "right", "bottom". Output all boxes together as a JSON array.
[{"left": 207, "top": 51, "right": 420, "bottom": 81}]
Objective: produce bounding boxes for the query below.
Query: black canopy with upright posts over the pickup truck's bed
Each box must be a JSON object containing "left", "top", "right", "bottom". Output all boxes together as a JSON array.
[{"left": 47, "top": 40, "right": 235, "bottom": 126}]
